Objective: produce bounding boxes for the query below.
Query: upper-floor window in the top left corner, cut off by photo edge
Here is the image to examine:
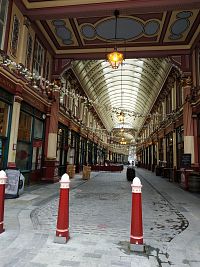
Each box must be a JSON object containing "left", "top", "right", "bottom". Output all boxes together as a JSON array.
[{"left": 0, "top": 0, "right": 8, "bottom": 49}]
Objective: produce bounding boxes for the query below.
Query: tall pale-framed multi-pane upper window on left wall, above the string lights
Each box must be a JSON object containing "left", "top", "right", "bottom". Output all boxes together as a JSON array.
[{"left": 33, "top": 40, "right": 44, "bottom": 76}]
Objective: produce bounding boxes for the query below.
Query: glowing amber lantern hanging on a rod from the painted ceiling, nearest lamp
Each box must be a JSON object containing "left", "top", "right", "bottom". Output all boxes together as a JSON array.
[{"left": 107, "top": 10, "right": 124, "bottom": 69}]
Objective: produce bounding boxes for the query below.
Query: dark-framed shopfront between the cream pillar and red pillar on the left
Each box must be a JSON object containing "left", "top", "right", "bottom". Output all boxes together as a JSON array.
[{"left": 16, "top": 102, "right": 44, "bottom": 184}]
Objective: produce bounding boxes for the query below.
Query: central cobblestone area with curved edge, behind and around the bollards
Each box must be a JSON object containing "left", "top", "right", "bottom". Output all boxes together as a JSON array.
[{"left": 31, "top": 172, "right": 188, "bottom": 245}]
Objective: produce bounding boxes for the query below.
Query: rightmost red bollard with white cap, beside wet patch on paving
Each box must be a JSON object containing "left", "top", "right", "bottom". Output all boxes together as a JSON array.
[{"left": 130, "top": 177, "right": 144, "bottom": 252}]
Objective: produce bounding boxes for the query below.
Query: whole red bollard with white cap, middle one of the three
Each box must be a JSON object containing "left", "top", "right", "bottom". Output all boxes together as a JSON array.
[{"left": 54, "top": 173, "right": 70, "bottom": 244}]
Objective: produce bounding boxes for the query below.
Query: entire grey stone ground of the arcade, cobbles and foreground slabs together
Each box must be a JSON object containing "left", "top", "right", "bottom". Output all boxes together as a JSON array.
[{"left": 0, "top": 168, "right": 200, "bottom": 267}]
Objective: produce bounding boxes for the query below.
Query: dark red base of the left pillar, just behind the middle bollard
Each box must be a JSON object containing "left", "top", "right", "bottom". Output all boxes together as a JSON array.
[{"left": 41, "top": 160, "right": 60, "bottom": 183}]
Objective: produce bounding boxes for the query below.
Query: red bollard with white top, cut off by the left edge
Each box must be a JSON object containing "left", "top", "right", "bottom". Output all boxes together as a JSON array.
[{"left": 0, "top": 171, "right": 7, "bottom": 234}]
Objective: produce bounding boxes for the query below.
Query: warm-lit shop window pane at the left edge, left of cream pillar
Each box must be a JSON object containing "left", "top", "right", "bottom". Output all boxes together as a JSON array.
[{"left": 0, "top": 101, "right": 9, "bottom": 137}]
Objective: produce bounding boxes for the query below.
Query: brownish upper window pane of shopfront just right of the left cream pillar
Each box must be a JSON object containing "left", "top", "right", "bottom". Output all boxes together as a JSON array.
[{"left": 18, "top": 112, "right": 32, "bottom": 142}]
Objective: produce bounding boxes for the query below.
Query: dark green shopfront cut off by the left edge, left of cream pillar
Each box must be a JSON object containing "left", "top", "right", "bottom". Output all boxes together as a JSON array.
[{"left": 0, "top": 88, "right": 13, "bottom": 170}]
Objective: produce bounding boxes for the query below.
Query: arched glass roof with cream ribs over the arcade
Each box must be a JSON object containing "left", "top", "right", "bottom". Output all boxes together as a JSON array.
[{"left": 73, "top": 58, "right": 172, "bottom": 134}]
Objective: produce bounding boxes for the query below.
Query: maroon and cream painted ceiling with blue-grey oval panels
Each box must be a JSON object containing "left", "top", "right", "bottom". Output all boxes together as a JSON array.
[{"left": 16, "top": 0, "right": 200, "bottom": 59}]
